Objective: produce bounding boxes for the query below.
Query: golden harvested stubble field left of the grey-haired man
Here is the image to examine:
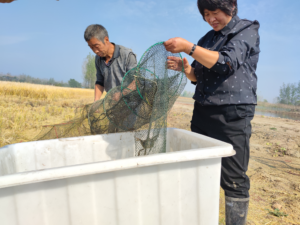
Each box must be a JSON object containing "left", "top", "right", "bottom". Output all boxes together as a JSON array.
[{"left": 0, "top": 81, "right": 105, "bottom": 147}]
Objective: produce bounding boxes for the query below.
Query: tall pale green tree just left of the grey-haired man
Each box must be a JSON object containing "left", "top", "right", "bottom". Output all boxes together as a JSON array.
[{"left": 82, "top": 53, "right": 96, "bottom": 88}]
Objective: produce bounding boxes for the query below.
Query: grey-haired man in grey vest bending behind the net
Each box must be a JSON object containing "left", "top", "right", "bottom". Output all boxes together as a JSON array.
[{"left": 84, "top": 24, "right": 137, "bottom": 101}]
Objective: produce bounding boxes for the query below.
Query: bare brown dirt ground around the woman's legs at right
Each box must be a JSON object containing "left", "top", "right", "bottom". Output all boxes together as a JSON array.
[{"left": 168, "top": 97, "right": 300, "bottom": 225}]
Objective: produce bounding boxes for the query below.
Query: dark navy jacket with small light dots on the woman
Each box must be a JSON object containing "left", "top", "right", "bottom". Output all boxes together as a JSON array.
[{"left": 191, "top": 16, "right": 260, "bottom": 105}]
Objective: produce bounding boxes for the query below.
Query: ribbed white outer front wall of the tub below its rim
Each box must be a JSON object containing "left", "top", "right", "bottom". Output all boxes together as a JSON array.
[{"left": 0, "top": 158, "right": 221, "bottom": 225}]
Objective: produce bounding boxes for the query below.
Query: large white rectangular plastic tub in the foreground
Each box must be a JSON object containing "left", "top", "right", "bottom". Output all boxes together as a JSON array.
[{"left": 0, "top": 128, "right": 235, "bottom": 225}]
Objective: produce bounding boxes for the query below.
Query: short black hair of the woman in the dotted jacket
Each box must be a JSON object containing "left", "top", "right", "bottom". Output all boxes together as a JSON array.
[{"left": 197, "top": 0, "right": 238, "bottom": 21}]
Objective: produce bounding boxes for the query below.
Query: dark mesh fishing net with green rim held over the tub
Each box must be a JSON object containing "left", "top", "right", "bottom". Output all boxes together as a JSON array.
[{"left": 35, "top": 42, "right": 186, "bottom": 156}]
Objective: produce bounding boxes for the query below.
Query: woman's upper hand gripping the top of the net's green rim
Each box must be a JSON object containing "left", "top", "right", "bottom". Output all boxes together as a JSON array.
[{"left": 164, "top": 37, "right": 194, "bottom": 54}]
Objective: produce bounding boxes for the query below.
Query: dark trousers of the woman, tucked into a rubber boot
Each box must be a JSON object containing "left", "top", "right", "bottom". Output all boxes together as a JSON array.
[{"left": 191, "top": 102, "right": 255, "bottom": 198}]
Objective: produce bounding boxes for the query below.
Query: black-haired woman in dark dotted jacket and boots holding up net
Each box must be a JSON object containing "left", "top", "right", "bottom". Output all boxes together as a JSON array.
[{"left": 164, "top": 0, "right": 260, "bottom": 225}]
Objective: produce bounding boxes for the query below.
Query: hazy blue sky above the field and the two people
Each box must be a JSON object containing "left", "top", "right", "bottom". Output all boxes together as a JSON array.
[{"left": 0, "top": 0, "right": 300, "bottom": 101}]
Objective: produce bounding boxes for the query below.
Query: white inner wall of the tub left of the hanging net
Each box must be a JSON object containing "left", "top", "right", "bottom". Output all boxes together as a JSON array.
[{"left": 0, "top": 133, "right": 134, "bottom": 177}]
